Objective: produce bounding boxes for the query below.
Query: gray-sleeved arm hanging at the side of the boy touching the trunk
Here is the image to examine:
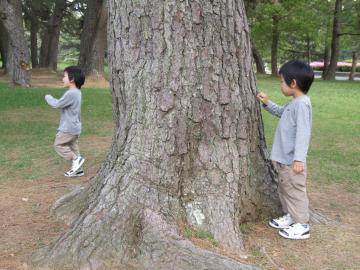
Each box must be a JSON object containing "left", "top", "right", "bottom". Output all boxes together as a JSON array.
[{"left": 293, "top": 103, "right": 311, "bottom": 173}]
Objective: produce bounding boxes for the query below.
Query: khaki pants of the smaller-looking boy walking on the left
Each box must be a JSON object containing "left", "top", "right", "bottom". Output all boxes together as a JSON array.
[{"left": 54, "top": 131, "right": 80, "bottom": 160}]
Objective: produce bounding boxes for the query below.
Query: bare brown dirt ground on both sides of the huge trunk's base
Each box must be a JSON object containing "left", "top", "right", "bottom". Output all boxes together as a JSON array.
[{"left": 0, "top": 166, "right": 360, "bottom": 270}]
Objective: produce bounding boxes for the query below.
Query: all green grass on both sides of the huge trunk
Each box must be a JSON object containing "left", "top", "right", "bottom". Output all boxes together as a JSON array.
[{"left": 0, "top": 77, "right": 360, "bottom": 186}]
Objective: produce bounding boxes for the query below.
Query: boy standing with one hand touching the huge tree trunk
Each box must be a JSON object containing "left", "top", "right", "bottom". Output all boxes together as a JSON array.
[{"left": 257, "top": 60, "right": 314, "bottom": 239}]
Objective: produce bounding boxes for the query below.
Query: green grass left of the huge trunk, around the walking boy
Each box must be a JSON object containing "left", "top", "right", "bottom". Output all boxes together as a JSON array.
[{"left": 0, "top": 82, "right": 112, "bottom": 180}]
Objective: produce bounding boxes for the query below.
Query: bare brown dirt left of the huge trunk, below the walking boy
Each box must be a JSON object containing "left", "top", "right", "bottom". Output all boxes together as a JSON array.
[{"left": 0, "top": 136, "right": 111, "bottom": 270}]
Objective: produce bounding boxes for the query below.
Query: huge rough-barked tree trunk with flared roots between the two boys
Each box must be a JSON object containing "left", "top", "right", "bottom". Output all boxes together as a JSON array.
[{"left": 33, "top": 0, "right": 280, "bottom": 270}]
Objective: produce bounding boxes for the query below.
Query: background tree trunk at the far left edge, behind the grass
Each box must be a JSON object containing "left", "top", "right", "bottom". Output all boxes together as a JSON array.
[{"left": 0, "top": 0, "right": 30, "bottom": 87}]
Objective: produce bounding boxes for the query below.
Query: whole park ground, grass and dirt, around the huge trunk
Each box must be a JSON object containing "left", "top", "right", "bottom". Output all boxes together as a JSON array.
[{"left": 0, "top": 71, "right": 360, "bottom": 270}]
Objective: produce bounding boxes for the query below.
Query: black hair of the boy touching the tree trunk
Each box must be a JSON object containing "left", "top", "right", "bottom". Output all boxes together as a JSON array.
[{"left": 279, "top": 60, "right": 314, "bottom": 94}]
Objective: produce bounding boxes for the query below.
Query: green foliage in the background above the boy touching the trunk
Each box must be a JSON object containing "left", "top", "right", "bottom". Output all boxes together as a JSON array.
[{"left": 248, "top": 0, "right": 360, "bottom": 63}]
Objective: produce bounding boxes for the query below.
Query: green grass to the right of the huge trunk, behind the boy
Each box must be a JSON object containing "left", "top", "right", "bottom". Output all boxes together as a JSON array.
[{"left": 258, "top": 78, "right": 360, "bottom": 184}]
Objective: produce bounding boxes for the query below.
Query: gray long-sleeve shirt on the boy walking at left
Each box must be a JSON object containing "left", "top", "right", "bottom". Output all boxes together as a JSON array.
[{"left": 45, "top": 88, "right": 81, "bottom": 135}]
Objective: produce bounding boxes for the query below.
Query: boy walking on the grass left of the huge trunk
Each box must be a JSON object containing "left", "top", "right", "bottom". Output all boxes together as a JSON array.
[{"left": 45, "top": 66, "right": 85, "bottom": 177}]
